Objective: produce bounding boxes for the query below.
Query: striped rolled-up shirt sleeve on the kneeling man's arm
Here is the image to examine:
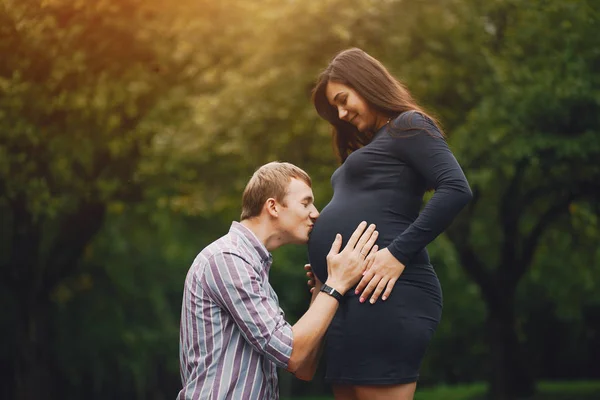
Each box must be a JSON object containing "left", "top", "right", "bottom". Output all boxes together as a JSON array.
[{"left": 205, "top": 252, "right": 293, "bottom": 368}]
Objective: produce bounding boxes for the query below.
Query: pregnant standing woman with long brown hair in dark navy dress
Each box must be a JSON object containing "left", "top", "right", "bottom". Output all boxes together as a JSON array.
[{"left": 309, "top": 48, "right": 472, "bottom": 400}]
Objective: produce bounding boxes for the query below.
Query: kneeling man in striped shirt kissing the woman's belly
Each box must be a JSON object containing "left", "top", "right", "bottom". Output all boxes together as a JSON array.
[{"left": 177, "top": 162, "right": 377, "bottom": 400}]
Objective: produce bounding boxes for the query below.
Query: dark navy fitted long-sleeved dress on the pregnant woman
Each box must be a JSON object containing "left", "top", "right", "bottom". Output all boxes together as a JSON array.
[{"left": 308, "top": 111, "right": 471, "bottom": 385}]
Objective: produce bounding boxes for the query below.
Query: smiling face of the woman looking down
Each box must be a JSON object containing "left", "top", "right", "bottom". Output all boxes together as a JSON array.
[{"left": 325, "top": 81, "right": 387, "bottom": 132}]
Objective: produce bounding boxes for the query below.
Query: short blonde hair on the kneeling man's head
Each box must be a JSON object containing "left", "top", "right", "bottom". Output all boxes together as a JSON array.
[{"left": 240, "top": 161, "right": 312, "bottom": 221}]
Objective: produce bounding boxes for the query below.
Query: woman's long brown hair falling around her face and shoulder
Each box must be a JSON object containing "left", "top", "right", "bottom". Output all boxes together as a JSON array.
[{"left": 312, "top": 48, "right": 441, "bottom": 163}]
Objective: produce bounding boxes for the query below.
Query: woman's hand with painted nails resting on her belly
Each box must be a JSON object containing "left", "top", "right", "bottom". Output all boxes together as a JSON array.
[{"left": 355, "top": 248, "right": 405, "bottom": 304}]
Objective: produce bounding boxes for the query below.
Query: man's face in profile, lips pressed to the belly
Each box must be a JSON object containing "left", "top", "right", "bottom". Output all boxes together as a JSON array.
[{"left": 278, "top": 179, "right": 319, "bottom": 244}]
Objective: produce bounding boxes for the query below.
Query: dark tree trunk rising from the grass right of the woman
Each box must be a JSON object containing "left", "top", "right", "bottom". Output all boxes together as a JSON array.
[{"left": 487, "top": 290, "right": 535, "bottom": 400}]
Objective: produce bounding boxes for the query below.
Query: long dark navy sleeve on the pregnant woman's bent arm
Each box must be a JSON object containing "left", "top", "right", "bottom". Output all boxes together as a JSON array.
[{"left": 388, "top": 112, "right": 472, "bottom": 265}]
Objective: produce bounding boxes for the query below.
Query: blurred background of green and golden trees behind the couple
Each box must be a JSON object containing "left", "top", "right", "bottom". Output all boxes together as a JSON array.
[{"left": 0, "top": 0, "right": 600, "bottom": 400}]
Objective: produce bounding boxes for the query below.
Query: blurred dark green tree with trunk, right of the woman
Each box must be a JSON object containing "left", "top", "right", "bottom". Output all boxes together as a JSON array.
[{"left": 436, "top": 1, "right": 600, "bottom": 399}]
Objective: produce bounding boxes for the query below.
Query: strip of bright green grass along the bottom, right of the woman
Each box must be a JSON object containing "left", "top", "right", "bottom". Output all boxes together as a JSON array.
[{"left": 281, "top": 381, "right": 600, "bottom": 400}]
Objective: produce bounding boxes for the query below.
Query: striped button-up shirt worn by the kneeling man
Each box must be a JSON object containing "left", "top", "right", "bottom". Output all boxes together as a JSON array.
[{"left": 177, "top": 222, "right": 292, "bottom": 400}]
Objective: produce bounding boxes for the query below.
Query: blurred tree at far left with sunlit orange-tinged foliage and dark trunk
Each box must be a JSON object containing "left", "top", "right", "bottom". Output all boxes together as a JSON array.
[{"left": 0, "top": 0, "right": 239, "bottom": 399}]
